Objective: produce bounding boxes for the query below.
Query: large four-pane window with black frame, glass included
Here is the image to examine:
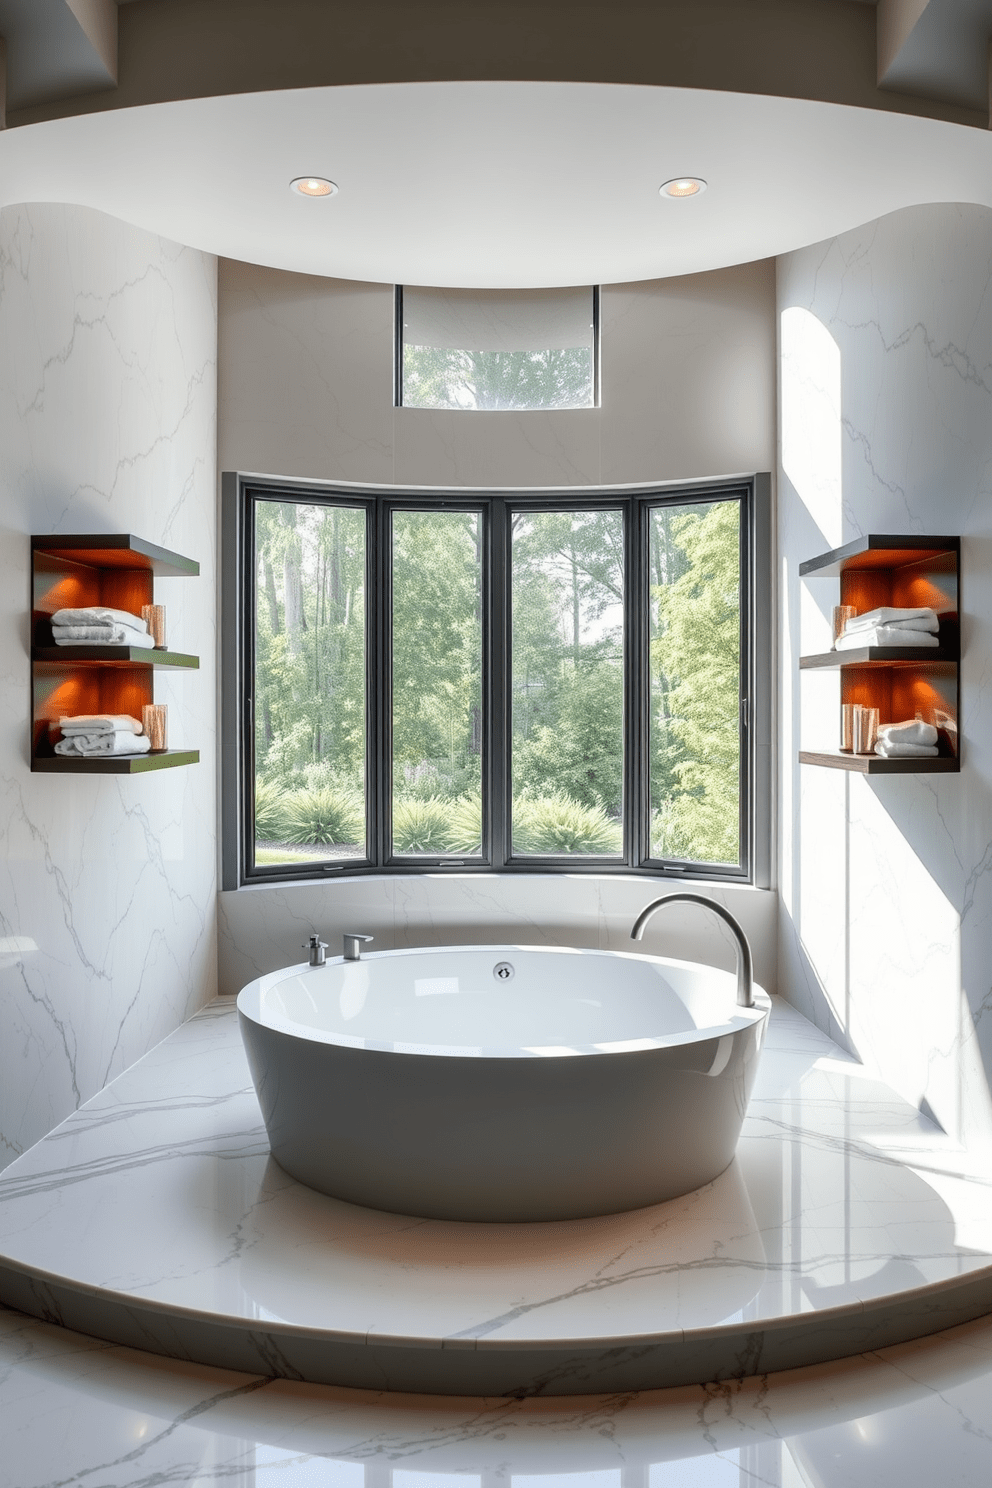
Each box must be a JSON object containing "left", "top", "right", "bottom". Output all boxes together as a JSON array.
[{"left": 225, "top": 476, "right": 767, "bottom": 887}]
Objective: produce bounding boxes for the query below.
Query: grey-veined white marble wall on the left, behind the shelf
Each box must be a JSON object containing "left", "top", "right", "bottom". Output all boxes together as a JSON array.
[{"left": 0, "top": 205, "right": 216, "bottom": 1165}]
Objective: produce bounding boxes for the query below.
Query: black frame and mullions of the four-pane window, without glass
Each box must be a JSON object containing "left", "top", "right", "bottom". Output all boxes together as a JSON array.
[{"left": 222, "top": 472, "right": 772, "bottom": 888}]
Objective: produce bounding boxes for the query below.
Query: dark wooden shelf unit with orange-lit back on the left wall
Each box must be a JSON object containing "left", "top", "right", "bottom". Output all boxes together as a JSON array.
[{"left": 31, "top": 533, "right": 199, "bottom": 775}]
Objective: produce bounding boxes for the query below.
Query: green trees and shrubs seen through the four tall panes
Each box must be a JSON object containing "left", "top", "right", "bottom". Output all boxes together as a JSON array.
[{"left": 254, "top": 500, "right": 741, "bottom": 863}]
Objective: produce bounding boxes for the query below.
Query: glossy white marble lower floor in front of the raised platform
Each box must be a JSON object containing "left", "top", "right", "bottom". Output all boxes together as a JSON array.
[{"left": 0, "top": 1311, "right": 992, "bottom": 1488}]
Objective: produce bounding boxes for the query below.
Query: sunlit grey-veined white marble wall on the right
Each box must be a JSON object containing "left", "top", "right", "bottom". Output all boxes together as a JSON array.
[{"left": 778, "top": 205, "right": 992, "bottom": 1149}]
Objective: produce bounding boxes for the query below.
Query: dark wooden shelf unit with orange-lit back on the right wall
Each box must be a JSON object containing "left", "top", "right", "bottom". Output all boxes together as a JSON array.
[{"left": 799, "top": 534, "right": 961, "bottom": 775}]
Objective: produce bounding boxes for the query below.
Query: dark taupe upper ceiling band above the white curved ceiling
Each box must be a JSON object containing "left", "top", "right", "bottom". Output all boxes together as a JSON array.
[{"left": 0, "top": 0, "right": 988, "bottom": 128}]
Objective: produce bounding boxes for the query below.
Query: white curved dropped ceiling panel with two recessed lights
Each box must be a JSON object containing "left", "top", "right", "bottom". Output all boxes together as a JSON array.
[{"left": 0, "top": 82, "right": 992, "bottom": 289}]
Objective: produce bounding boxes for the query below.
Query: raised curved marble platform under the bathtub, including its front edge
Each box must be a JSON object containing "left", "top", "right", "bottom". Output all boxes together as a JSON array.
[{"left": 0, "top": 1001, "right": 992, "bottom": 1396}]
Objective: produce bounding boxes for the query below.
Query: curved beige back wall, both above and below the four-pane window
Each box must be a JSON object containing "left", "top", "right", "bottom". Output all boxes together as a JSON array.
[{"left": 219, "top": 259, "right": 776, "bottom": 992}]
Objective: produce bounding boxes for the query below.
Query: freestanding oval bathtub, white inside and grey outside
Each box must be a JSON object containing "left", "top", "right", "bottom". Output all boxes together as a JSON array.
[{"left": 238, "top": 945, "right": 770, "bottom": 1220}]
